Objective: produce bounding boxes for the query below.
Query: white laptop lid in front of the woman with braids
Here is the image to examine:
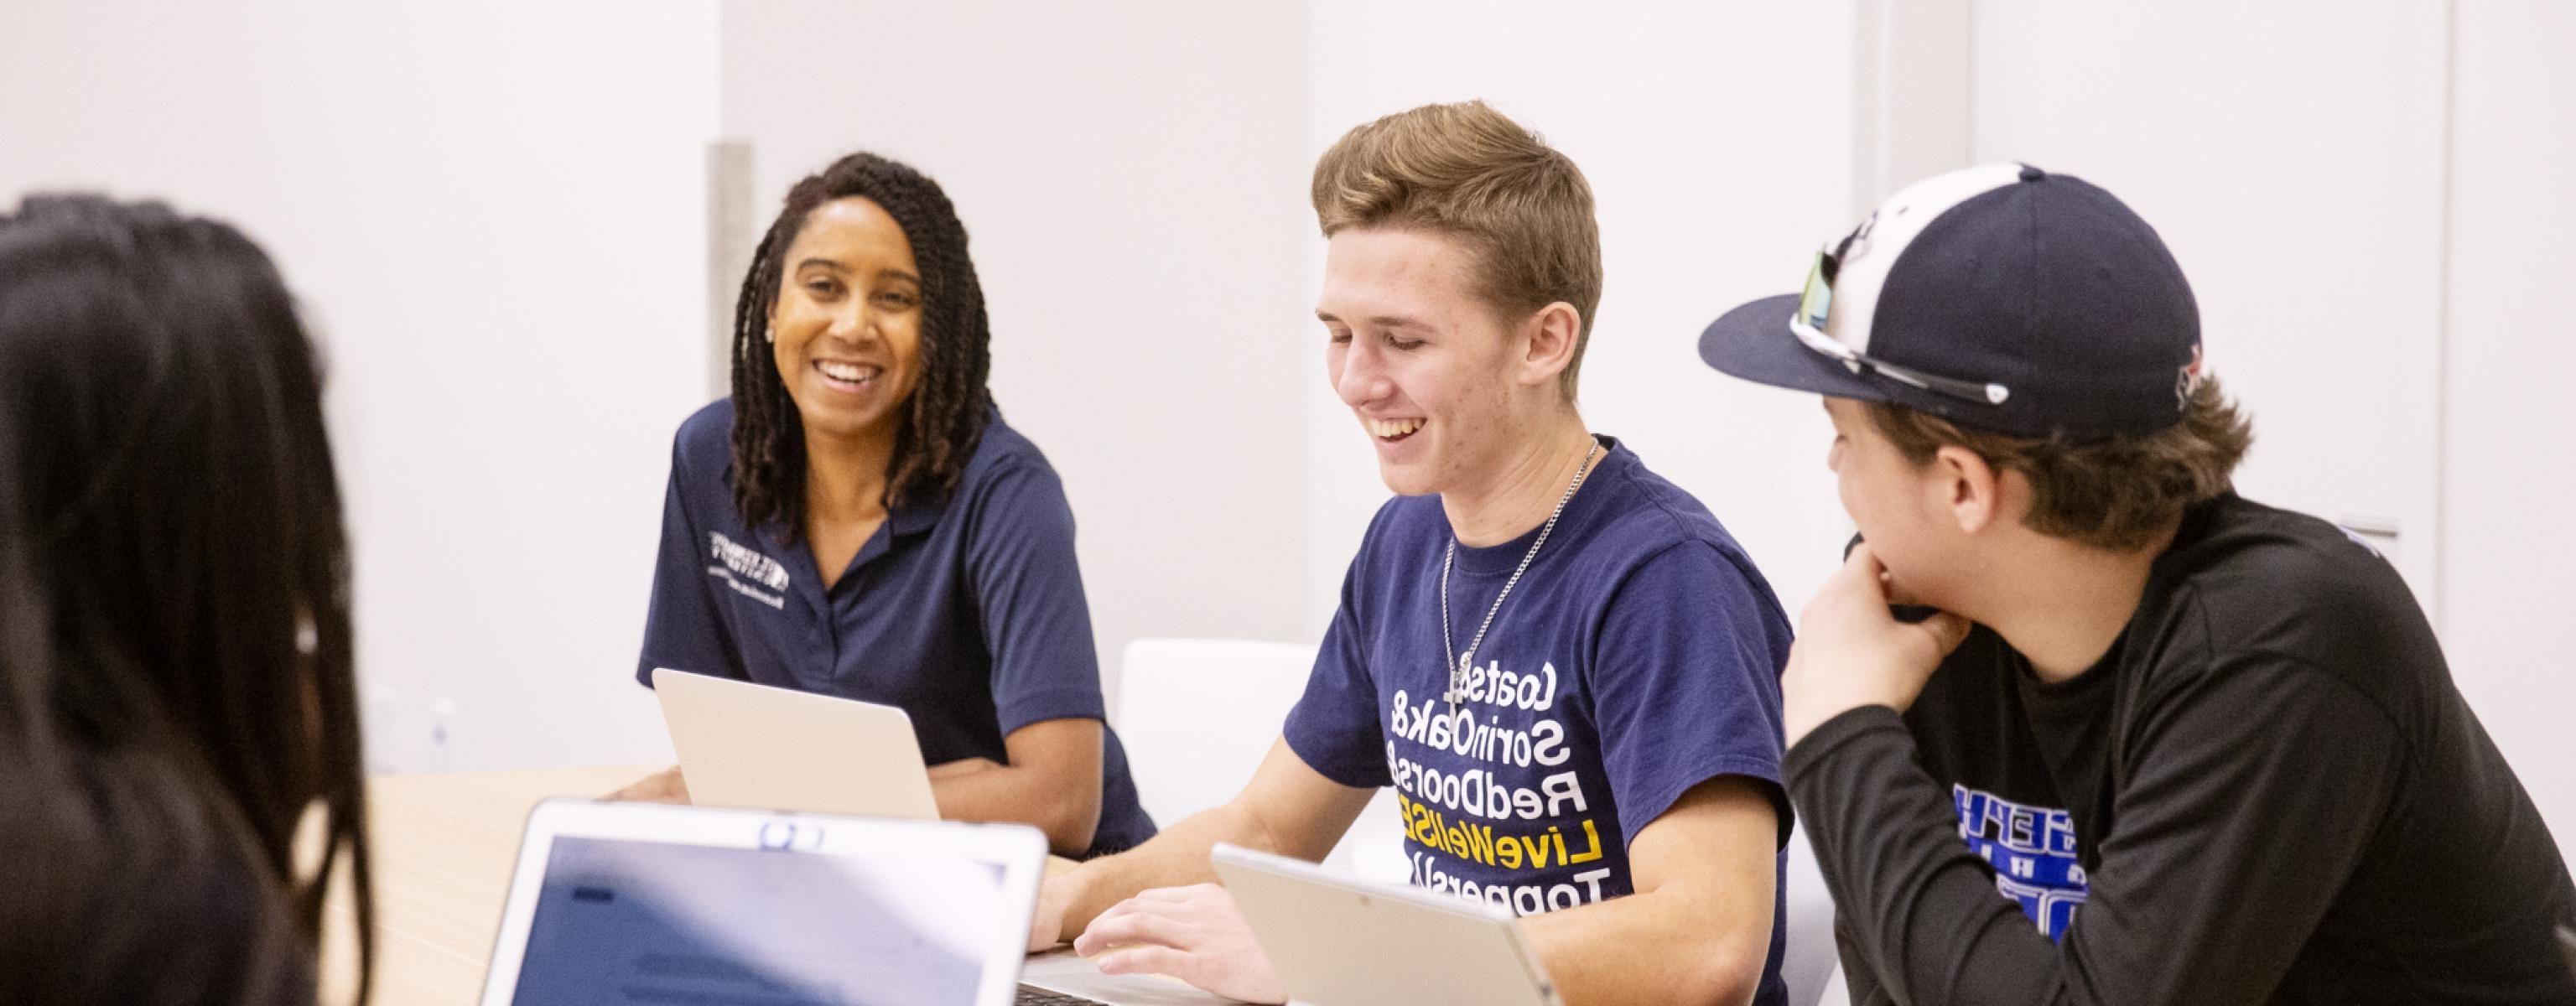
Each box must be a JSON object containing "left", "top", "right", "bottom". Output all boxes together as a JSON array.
[{"left": 652, "top": 666, "right": 940, "bottom": 821}]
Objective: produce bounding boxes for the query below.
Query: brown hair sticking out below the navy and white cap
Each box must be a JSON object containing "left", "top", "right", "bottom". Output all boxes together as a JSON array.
[{"left": 1865, "top": 378, "right": 2254, "bottom": 551}]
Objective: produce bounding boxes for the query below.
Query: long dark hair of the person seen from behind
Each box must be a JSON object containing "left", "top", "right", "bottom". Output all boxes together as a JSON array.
[{"left": 0, "top": 195, "right": 373, "bottom": 1001}]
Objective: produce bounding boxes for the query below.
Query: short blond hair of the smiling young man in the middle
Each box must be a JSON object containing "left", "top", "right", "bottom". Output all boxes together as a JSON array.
[{"left": 1314, "top": 101, "right": 1602, "bottom": 402}]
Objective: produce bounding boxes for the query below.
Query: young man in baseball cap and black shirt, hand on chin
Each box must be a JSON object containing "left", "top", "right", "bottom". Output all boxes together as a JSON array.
[{"left": 1701, "top": 164, "right": 2576, "bottom": 1003}]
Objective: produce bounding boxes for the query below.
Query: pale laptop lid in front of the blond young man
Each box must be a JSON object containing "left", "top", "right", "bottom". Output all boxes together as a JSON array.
[{"left": 1211, "top": 844, "right": 1564, "bottom": 1006}]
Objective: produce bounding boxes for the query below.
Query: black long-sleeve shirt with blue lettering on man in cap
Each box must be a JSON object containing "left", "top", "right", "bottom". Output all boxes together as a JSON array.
[{"left": 1788, "top": 494, "right": 2576, "bottom": 1006}]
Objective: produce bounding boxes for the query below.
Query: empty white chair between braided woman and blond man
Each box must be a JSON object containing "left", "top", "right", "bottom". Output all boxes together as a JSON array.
[{"left": 1115, "top": 638, "right": 1406, "bottom": 883}]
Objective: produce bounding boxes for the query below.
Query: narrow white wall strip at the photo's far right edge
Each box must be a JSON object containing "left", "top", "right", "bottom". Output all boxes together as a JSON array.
[{"left": 2442, "top": 3, "right": 2576, "bottom": 849}]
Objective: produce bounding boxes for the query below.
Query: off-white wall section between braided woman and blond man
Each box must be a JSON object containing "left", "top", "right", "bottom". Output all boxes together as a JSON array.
[{"left": 724, "top": 0, "right": 1322, "bottom": 710}]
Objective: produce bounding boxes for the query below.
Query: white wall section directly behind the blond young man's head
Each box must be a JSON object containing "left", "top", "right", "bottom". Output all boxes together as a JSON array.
[{"left": 1296, "top": 0, "right": 1855, "bottom": 628}]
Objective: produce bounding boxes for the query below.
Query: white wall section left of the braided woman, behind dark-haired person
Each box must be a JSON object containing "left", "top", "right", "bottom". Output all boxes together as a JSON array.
[{"left": 0, "top": 0, "right": 716, "bottom": 770}]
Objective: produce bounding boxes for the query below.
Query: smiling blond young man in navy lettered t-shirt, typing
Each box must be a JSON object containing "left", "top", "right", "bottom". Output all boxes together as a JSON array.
[{"left": 1031, "top": 103, "right": 1790, "bottom": 1003}]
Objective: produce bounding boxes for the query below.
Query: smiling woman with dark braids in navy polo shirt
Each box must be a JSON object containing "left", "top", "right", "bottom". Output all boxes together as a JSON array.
[{"left": 618, "top": 154, "right": 1154, "bottom": 857}]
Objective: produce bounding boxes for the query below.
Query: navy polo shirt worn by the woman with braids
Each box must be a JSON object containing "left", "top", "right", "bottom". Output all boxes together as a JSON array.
[{"left": 636, "top": 402, "right": 1154, "bottom": 854}]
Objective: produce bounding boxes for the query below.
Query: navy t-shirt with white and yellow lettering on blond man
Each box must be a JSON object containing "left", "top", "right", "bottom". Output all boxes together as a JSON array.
[{"left": 1283, "top": 438, "right": 1790, "bottom": 1003}]
